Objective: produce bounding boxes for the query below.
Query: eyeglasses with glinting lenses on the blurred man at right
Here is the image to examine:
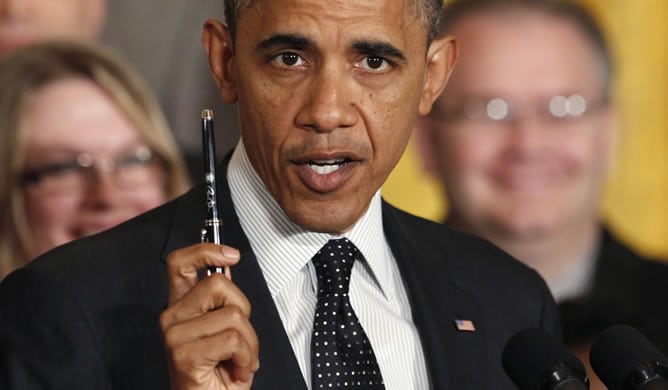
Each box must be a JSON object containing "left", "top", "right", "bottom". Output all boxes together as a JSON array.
[{"left": 439, "top": 94, "right": 607, "bottom": 126}]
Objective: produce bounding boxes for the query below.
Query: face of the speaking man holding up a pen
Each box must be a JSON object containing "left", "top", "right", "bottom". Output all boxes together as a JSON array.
[{"left": 205, "top": 0, "right": 451, "bottom": 232}]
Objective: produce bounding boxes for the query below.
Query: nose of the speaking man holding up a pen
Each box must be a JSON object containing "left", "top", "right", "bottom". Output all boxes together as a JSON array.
[{"left": 296, "top": 67, "right": 358, "bottom": 132}]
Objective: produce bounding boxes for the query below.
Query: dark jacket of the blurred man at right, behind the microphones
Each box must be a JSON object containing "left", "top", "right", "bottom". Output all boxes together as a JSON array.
[{"left": 559, "top": 228, "right": 668, "bottom": 354}]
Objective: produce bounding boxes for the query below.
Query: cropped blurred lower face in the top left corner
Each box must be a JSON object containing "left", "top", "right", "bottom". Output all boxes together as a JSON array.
[{"left": 0, "top": 0, "right": 106, "bottom": 58}]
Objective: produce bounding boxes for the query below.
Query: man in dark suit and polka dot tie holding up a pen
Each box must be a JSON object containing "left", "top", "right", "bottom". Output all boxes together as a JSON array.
[{"left": 0, "top": 0, "right": 558, "bottom": 389}]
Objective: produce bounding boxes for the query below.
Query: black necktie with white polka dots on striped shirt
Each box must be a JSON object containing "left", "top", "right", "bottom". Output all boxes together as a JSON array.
[{"left": 311, "top": 238, "right": 385, "bottom": 390}]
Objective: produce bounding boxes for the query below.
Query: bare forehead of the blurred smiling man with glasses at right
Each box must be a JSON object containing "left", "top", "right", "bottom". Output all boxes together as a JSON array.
[{"left": 448, "top": 11, "right": 602, "bottom": 94}]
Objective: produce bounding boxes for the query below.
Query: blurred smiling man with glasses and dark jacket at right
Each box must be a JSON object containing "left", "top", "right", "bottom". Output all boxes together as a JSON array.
[{"left": 417, "top": 0, "right": 668, "bottom": 380}]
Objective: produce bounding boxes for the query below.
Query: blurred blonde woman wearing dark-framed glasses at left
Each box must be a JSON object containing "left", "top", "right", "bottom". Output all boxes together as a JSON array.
[{"left": 0, "top": 42, "right": 189, "bottom": 279}]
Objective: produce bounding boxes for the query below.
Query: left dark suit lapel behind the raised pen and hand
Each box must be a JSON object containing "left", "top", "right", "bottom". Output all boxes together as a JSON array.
[{"left": 163, "top": 154, "right": 306, "bottom": 389}]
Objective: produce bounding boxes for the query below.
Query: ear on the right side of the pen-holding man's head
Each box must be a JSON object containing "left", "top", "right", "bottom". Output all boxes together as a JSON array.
[{"left": 418, "top": 35, "right": 457, "bottom": 115}]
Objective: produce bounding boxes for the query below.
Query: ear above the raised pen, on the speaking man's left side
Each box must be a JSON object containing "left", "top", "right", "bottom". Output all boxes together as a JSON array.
[{"left": 202, "top": 19, "right": 238, "bottom": 104}]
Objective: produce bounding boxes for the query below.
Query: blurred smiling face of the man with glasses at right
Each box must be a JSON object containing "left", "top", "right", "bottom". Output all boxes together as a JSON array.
[{"left": 425, "top": 13, "right": 614, "bottom": 239}]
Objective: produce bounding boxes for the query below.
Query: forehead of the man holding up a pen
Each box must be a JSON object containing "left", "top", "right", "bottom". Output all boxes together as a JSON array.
[{"left": 237, "top": 0, "right": 427, "bottom": 50}]
